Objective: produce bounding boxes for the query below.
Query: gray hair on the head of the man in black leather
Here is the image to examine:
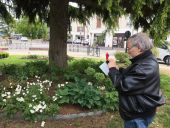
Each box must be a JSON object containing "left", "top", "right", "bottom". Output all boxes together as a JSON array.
[{"left": 128, "top": 33, "right": 153, "bottom": 52}]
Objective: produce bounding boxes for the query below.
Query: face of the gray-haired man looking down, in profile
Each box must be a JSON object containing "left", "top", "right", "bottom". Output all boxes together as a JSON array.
[{"left": 127, "top": 40, "right": 142, "bottom": 58}]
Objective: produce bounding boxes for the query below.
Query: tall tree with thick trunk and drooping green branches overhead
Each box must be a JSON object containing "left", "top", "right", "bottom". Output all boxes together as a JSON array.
[{"left": 0, "top": 0, "right": 170, "bottom": 67}]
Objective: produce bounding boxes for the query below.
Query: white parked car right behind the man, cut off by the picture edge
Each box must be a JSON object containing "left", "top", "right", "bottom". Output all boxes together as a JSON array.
[{"left": 157, "top": 44, "right": 170, "bottom": 65}]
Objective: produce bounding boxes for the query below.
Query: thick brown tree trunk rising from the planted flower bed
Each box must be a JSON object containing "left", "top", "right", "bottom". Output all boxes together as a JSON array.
[{"left": 49, "top": 0, "right": 68, "bottom": 68}]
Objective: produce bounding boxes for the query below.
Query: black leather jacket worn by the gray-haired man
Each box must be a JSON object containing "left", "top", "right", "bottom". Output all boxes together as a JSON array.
[{"left": 109, "top": 50, "right": 165, "bottom": 120}]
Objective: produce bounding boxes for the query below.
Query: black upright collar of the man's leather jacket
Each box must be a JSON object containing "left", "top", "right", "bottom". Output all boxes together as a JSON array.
[{"left": 130, "top": 50, "right": 152, "bottom": 63}]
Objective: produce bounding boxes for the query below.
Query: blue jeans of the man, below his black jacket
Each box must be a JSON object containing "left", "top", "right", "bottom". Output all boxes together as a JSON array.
[{"left": 124, "top": 116, "right": 154, "bottom": 128}]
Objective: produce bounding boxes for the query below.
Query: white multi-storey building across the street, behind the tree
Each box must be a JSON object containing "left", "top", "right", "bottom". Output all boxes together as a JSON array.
[{"left": 69, "top": 15, "right": 141, "bottom": 48}]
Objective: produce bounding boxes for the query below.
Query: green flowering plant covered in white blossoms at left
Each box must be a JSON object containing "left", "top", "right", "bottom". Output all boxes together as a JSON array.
[{"left": 0, "top": 77, "right": 59, "bottom": 121}]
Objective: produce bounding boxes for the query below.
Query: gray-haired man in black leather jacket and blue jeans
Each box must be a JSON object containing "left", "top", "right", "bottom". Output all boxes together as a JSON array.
[{"left": 108, "top": 33, "right": 165, "bottom": 128}]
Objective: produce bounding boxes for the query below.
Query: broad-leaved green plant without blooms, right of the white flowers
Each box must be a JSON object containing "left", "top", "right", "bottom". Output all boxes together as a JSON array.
[{"left": 56, "top": 79, "right": 102, "bottom": 108}]
